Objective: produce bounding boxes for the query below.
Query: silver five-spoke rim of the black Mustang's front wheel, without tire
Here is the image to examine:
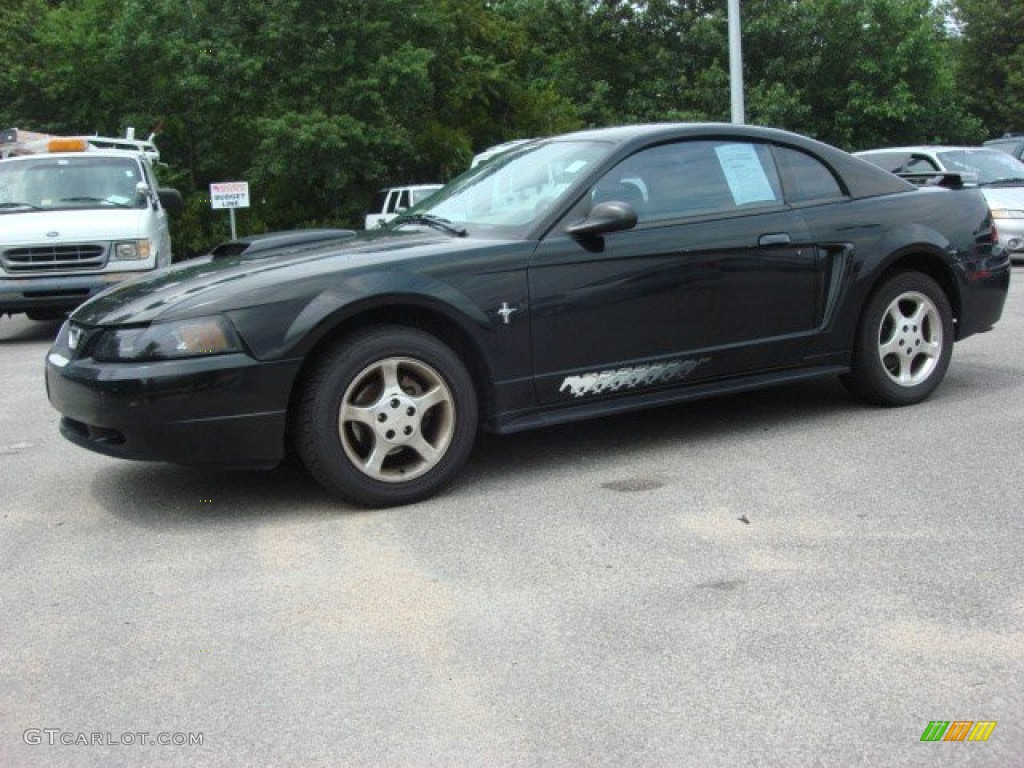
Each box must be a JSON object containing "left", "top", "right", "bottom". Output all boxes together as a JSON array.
[{"left": 338, "top": 357, "right": 456, "bottom": 482}]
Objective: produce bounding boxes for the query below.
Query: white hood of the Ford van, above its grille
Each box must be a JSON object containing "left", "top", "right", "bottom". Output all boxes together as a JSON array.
[{"left": 0, "top": 208, "right": 146, "bottom": 247}]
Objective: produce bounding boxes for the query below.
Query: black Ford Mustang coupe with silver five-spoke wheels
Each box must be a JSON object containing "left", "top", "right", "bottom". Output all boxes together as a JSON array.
[{"left": 46, "top": 124, "right": 1010, "bottom": 505}]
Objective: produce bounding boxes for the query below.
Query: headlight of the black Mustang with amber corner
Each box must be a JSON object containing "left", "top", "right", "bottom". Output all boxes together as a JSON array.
[{"left": 92, "top": 315, "right": 242, "bottom": 362}]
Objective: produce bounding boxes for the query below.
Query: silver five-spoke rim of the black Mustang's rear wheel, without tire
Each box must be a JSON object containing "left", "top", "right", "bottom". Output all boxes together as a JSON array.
[{"left": 879, "top": 291, "right": 943, "bottom": 387}]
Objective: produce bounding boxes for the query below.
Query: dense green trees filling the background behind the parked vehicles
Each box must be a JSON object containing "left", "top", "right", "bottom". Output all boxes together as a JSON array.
[{"left": 0, "top": 0, "right": 1007, "bottom": 251}]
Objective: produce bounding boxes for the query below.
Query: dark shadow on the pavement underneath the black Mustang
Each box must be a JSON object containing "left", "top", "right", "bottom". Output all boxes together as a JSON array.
[{"left": 86, "top": 372, "right": 1007, "bottom": 528}]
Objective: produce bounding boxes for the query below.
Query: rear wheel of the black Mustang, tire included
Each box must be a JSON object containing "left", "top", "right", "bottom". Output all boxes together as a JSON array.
[{"left": 843, "top": 272, "right": 953, "bottom": 406}]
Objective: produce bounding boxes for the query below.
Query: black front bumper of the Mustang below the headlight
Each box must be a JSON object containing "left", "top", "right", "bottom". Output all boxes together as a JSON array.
[{"left": 46, "top": 344, "right": 300, "bottom": 468}]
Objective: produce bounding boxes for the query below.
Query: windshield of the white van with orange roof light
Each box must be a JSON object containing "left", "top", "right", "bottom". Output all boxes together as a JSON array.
[{"left": 0, "top": 156, "right": 146, "bottom": 213}]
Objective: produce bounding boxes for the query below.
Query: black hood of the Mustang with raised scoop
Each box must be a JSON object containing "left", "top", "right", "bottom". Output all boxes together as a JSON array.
[{"left": 72, "top": 230, "right": 509, "bottom": 326}]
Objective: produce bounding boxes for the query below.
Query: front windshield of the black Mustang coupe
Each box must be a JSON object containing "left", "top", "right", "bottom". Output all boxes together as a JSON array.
[{"left": 392, "top": 141, "right": 611, "bottom": 237}]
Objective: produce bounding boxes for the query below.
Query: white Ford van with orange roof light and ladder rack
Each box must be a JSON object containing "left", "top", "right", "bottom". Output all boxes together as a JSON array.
[{"left": 0, "top": 129, "right": 182, "bottom": 319}]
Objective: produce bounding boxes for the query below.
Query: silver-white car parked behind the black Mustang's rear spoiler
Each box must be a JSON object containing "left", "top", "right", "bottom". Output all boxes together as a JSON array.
[{"left": 854, "top": 145, "right": 1024, "bottom": 260}]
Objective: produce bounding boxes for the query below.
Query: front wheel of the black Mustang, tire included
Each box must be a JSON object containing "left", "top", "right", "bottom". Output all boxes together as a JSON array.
[{"left": 294, "top": 326, "right": 478, "bottom": 507}]
